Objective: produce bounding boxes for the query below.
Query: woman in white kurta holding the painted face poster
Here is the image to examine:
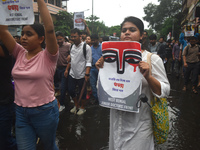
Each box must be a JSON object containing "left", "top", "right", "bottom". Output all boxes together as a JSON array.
[{"left": 96, "top": 17, "right": 170, "bottom": 150}]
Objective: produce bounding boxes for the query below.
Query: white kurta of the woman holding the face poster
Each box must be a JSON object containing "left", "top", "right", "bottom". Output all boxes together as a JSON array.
[{"left": 109, "top": 51, "right": 170, "bottom": 150}]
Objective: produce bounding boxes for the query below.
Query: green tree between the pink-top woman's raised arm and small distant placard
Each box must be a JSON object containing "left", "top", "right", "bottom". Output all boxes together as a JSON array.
[{"left": 54, "top": 11, "right": 73, "bottom": 35}]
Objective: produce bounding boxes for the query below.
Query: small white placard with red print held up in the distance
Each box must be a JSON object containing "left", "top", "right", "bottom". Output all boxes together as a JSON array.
[{"left": 74, "top": 12, "right": 85, "bottom": 30}]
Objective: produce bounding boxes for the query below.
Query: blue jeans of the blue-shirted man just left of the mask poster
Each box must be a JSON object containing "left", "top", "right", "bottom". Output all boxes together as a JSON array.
[{"left": 90, "top": 66, "right": 99, "bottom": 100}]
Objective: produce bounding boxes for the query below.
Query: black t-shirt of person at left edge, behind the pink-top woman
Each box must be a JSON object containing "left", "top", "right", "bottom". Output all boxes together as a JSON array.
[{"left": 0, "top": 43, "right": 14, "bottom": 105}]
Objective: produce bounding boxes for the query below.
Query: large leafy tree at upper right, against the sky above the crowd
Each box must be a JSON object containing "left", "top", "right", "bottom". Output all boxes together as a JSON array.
[{"left": 143, "top": 0, "right": 183, "bottom": 37}]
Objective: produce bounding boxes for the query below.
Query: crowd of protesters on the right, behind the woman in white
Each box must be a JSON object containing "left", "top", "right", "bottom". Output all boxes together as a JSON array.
[{"left": 144, "top": 25, "right": 200, "bottom": 94}]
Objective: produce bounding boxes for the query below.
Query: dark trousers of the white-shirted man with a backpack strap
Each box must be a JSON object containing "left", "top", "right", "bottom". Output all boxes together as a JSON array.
[{"left": 68, "top": 75, "right": 86, "bottom": 99}]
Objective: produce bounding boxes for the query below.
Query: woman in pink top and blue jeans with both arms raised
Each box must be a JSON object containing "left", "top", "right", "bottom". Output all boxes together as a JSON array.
[{"left": 0, "top": 0, "right": 59, "bottom": 150}]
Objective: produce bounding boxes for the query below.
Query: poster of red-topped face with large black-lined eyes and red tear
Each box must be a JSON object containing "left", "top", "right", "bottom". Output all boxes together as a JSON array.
[{"left": 98, "top": 41, "right": 142, "bottom": 113}]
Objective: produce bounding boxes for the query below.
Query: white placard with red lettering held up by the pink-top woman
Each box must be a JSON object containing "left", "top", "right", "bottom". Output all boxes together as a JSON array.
[{"left": 0, "top": 0, "right": 34, "bottom": 25}]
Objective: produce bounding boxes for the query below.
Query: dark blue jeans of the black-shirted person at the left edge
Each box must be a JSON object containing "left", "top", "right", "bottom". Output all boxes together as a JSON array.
[{"left": 0, "top": 103, "right": 17, "bottom": 150}]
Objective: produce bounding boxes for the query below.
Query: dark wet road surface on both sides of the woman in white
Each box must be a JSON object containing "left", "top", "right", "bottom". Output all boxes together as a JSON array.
[{"left": 38, "top": 75, "right": 200, "bottom": 150}]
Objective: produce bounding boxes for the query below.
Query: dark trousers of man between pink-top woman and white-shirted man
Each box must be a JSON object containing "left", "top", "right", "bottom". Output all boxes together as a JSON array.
[{"left": 54, "top": 66, "right": 68, "bottom": 105}]
